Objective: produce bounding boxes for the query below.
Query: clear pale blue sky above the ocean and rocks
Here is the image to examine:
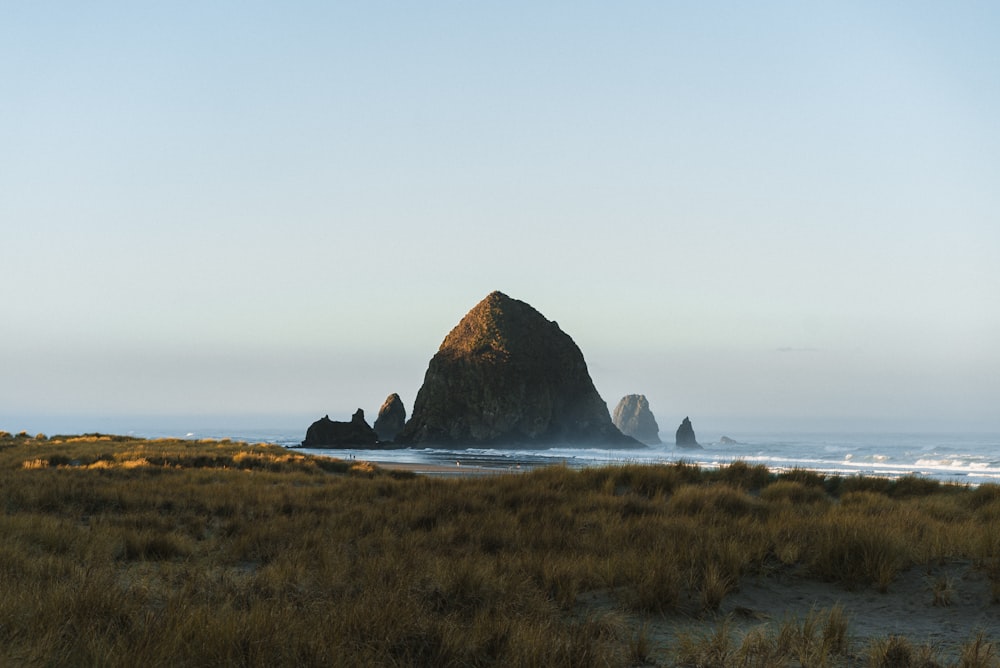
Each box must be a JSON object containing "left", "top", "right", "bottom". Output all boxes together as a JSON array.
[{"left": 0, "top": 0, "right": 1000, "bottom": 434}]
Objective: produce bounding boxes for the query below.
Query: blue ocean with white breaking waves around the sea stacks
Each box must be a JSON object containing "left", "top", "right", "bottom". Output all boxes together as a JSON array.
[{"left": 113, "top": 428, "right": 1000, "bottom": 484}]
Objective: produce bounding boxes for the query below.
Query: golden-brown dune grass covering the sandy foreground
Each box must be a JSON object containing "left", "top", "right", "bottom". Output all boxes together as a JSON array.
[{"left": 0, "top": 433, "right": 1000, "bottom": 668}]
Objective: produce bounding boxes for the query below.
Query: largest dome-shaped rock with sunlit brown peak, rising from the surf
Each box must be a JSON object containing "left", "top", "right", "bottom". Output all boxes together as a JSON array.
[{"left": 397, "top": 292, "right": 640, "bottom": 448}]
